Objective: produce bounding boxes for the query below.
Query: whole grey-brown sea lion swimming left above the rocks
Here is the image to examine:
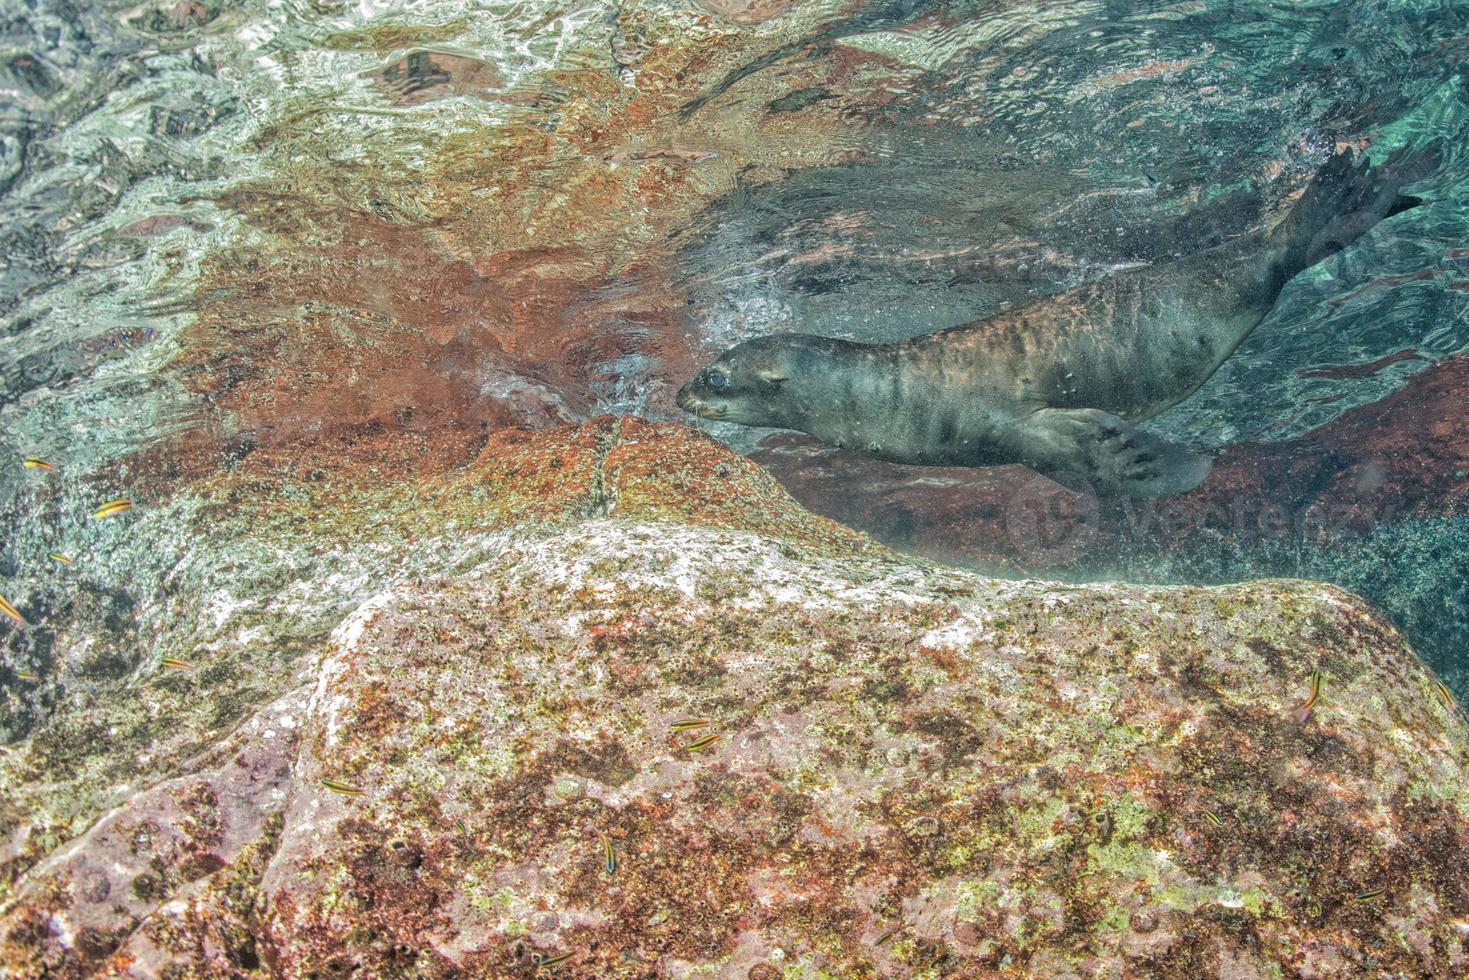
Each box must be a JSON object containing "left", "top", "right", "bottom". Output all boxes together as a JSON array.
[{"left": 677, "top": 151, "right": 1422, "bottom": 497}]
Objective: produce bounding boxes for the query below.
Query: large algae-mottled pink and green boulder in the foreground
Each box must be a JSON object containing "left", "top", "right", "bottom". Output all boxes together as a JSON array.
[{"left": 0, "top": 420, "right": 1469, "bottom": 977}]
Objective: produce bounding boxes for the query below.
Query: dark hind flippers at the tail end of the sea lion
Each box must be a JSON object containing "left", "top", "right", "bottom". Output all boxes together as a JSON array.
[{"left": 1271, "top": 150, "right": 1438, "bottom": 284}]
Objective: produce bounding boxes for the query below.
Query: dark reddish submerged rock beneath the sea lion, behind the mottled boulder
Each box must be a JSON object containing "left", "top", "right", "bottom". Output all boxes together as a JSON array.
[{"left": 754, "top": 356, "right": 1469, "bottom": 695}]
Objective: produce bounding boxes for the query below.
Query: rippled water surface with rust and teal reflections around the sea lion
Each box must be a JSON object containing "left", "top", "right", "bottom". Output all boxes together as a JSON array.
[{"left": 0, "top": 0, "right": 1469, "bottom": 758}]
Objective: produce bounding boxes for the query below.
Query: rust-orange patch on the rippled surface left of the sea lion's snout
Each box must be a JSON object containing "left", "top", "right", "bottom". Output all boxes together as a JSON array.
[{"left": 152, "top": 1, "right": 906, "bottom": 499}]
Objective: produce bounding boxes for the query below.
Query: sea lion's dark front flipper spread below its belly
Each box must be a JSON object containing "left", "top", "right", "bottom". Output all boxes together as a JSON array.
[{"left": 1015, "top": 408, "right": 1212, "bottom": 497}]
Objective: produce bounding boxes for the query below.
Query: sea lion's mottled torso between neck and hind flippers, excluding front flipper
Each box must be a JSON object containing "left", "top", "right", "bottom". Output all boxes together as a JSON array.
[{"left": 875, "top": 243, "right": 1274, "bottom": 464}]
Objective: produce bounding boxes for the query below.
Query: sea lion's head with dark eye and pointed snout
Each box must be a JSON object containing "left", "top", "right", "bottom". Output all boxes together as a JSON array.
[{"left": 677, "top": 334, "right": 802, "bottom": 428}]
